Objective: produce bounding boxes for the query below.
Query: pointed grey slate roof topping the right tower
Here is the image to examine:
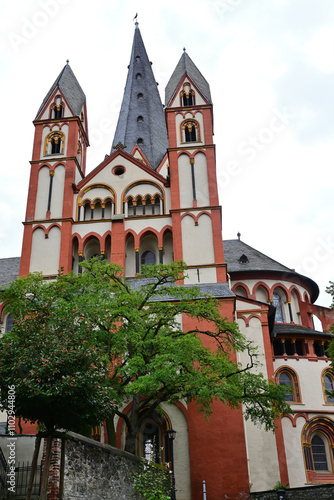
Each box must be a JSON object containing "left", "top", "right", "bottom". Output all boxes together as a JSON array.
[{"left": 165, "top": 51, "right": 212, "bottom": 106}]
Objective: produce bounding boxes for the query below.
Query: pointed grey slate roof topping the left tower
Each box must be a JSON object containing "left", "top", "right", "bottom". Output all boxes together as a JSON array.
[{"left": 35, "top": 64, "right": 86, "bottom": 120}]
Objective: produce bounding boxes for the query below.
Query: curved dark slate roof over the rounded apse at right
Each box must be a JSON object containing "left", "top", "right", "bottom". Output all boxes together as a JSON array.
[{"left": 223, "top": 239, "right": 319, "bottom": 302}]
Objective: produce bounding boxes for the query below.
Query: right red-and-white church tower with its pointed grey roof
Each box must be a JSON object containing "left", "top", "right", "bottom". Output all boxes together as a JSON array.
[{"left": 165, "top": 51, "right": 226, "bottom": 283}]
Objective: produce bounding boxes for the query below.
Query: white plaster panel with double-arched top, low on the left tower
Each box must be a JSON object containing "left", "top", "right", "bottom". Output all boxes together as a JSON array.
[{"left": 29, "top": 226, "right": 61, "bottom": 275}]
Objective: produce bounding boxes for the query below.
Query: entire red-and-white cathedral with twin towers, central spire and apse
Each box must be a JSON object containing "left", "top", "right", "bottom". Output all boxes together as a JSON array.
[{"left": 0, "top": 23, "right": 334, "bottom": 500}]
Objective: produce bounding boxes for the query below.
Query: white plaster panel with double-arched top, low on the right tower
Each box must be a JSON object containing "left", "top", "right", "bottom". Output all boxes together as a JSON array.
[{"left": 181, "top": 214, "right": 215, "bottom": 266}]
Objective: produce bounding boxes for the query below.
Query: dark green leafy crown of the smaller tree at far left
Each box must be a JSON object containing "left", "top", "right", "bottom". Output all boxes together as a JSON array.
[{"left": 0, "top": 274, "right": 116, "bottom": 432}]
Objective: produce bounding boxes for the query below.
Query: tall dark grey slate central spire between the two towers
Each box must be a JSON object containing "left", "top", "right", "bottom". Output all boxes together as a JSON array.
[{"left": 111, "top": 23, "right": 168, "bottom": 169}]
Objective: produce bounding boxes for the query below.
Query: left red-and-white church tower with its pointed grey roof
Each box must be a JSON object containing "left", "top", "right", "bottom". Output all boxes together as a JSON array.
[{"left": 20, "top": 63, "right": 89, "bottom": 276}]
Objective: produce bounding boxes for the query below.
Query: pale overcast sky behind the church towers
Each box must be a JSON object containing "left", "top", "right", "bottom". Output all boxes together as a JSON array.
[{"left": 0, "top": 0, "right": 334, "bottom": 305}]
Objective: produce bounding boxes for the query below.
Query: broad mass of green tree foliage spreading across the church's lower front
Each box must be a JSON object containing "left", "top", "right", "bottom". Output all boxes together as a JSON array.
[{"left": 0, "top": 259, "right": 289, "bottom": 453}]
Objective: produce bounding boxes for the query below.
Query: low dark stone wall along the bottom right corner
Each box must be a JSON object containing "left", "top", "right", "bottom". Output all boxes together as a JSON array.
[{"left": 251, "top": 484, "right": 334, "bottom": 500}]
